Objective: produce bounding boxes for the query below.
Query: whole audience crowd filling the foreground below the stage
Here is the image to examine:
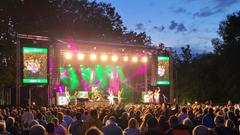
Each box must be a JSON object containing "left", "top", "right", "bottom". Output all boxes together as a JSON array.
[{"left": 0, "top": 104, "right": 240, "bottom": 135}]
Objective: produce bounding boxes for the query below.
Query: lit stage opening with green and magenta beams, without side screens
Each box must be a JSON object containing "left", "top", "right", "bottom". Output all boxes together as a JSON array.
[{"left": 55, "top": 41, "right": 152, "bottom": 105}]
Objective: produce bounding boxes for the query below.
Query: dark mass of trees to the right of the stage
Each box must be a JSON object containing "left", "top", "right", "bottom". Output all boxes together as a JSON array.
[{"left": 174, "top": 12, "right": 240, "bottom": 103}]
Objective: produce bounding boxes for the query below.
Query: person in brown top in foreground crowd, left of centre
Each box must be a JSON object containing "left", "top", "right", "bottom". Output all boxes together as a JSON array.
[{"left": 82, "top": 109, "right": 103, "bottom": 135}]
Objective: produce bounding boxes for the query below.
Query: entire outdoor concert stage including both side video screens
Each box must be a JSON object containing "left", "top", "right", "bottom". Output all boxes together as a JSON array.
[{"left": 16, "top": 35, "right": 173, "bottom": 105}]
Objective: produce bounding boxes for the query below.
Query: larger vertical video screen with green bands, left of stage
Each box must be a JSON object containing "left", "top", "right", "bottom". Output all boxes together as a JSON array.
[{"left": 22, "top": 47, "right": 48, "bottom": 84}]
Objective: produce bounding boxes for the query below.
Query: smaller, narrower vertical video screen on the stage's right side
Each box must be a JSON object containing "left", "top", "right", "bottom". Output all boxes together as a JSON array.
[{"left": 157, "top": 56, "right": 170, "bottom": 85}]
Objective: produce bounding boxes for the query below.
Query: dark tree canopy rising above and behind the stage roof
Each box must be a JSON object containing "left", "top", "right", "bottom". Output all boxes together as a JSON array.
[{"left": 0, "top": 0, "right": 151, "bottom": 45}]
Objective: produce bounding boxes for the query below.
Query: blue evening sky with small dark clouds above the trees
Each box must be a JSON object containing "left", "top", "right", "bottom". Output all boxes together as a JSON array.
[{"left": 97, "top": 0, "right": 240, "bottom": 53}]
